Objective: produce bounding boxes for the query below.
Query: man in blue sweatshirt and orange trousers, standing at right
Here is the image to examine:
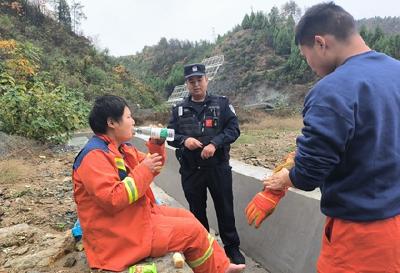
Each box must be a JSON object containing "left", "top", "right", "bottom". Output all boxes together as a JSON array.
[{"left": 264, "top": 2, "right": 400, "bottom": 273}]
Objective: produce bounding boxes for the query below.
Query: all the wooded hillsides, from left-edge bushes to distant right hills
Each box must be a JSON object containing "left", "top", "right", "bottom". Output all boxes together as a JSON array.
[{"left": 0, "top": 0, "right": 400, "bottom": 142}]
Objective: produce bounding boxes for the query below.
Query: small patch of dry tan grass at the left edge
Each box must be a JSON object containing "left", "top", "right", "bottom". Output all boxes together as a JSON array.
[{"left": 0, "top": 159, "right": 30, "bottom": 185}]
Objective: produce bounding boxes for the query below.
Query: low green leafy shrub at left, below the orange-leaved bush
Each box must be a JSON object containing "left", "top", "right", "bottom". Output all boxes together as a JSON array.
[{"left": 0, "top": 73, "right": 89, "bottom": 143}]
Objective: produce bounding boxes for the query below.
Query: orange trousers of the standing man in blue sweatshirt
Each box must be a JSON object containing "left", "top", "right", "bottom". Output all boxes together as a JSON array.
[{"left": 317, "top": 215, "right": 400, "bottom": 273}]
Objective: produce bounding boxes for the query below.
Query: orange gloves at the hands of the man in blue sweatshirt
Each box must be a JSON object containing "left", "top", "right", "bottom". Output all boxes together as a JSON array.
[{"left": 245, "top": 152, "right": 295, "bottom": 228}]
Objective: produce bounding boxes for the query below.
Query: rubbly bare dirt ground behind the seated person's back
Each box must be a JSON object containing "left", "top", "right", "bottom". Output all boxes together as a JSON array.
[{"left": 0, "top": 141, "right": 89, "bottom": 273}]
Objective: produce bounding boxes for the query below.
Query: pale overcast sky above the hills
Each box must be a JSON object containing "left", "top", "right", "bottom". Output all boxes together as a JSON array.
[{"left": 80, "top": 0, "right": 400, "bottom": 56}]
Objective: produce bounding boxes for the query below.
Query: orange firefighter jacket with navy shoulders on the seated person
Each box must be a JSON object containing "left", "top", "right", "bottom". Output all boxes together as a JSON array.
[{"left": 73, "top": 135, "right": 165, "bottom": 271}]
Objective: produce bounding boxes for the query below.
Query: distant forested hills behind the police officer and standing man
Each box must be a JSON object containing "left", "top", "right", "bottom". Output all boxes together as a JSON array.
[{"left": 120, "top": 1, "right": 400, "bottom": 108}]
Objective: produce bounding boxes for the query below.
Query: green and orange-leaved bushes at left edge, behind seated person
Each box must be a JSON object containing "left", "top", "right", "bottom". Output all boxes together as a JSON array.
[{"left": 0, "top": 40, "right": 89, "bottom": 142}]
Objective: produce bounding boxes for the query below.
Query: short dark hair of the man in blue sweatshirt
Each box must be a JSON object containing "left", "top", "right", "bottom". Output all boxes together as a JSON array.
[{"left": 295, "top": 2, "right": 356, "bottom": 46}]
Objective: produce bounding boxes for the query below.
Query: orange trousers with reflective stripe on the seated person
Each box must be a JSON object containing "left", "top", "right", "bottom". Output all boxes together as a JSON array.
[{"left": 151, "top": 206, "right": 229, "bottom": 273}]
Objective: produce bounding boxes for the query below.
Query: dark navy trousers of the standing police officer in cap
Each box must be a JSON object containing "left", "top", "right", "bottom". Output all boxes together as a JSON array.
[{"left": 179, "top": 162, "right": 240, "bottom": 249}]
